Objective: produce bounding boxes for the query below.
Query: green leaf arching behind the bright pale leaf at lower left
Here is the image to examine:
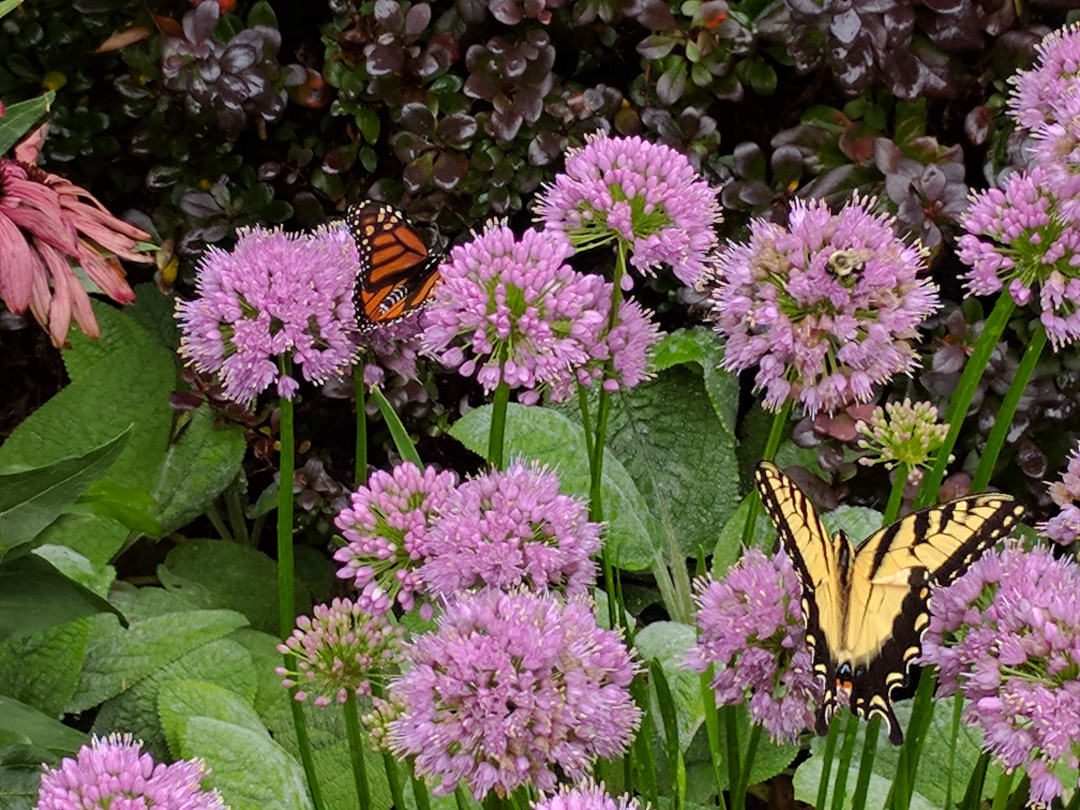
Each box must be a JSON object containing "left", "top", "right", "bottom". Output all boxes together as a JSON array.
[{"left": 93, "top": 638, "right": 258, "bottom": 758}]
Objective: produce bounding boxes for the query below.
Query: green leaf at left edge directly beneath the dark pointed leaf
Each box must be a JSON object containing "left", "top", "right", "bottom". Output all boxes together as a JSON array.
[{"left": 0, "top": 619, "right": 91, "bottom": 717}]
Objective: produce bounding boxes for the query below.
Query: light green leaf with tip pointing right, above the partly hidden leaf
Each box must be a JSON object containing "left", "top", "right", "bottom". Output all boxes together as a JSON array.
[{"left": 67, "top": 610, "right": 247, "bottom": 712}]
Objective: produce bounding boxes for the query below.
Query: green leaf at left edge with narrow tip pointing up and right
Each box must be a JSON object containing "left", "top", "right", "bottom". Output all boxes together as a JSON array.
[{"left": 0, "top": 430, "right": 129, "bottom": 559}]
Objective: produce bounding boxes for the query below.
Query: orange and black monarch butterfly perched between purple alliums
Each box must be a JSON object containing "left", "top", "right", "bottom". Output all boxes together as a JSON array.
[{"left": 346, "top": 200, "right": 443, "bottom": 328}]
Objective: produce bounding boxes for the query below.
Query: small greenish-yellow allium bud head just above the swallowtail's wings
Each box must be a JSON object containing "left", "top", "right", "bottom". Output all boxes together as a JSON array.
[{"left": 855, "top": 397, "right": 948, "bottom": 470}]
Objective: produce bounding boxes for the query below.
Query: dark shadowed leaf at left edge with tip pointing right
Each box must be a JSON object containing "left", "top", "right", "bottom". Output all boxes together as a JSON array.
[{"left": 0, "top": 554, "right": 123, "bottom": 640}]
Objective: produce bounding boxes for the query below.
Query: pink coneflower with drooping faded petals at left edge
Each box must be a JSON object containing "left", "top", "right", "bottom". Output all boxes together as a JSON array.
[{"left": 0, "top": 131, "right": 153, "bottom": 347}]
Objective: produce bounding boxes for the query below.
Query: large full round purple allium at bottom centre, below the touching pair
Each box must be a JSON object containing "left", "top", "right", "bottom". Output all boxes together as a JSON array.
[{"left": 382, "top": 589, "right": 640, "bottom": 799}]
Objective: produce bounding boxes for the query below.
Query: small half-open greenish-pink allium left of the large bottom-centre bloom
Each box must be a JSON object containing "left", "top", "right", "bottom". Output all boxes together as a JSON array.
[{"left": 274, "top": 599, "right": 401, "bottom": 706}]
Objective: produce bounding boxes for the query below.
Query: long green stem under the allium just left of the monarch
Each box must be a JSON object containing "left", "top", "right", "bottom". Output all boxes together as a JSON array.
[{"left": 278, "top": 384, "right": 323, "bottom": 810}]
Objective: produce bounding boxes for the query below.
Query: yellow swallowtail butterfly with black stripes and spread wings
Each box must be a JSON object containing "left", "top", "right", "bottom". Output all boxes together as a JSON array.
[{"left": 755, "top": 462, "right": 1023, "bottom": 745}]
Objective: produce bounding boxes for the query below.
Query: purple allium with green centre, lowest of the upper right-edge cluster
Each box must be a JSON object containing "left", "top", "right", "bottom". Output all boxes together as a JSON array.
[{"left": 959, "top": 166, "right": 1080, "bottom": 347}]
